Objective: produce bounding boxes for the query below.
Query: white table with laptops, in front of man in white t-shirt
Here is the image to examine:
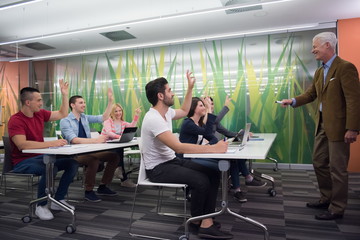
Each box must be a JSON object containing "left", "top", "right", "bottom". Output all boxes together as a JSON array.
[{"left": 183, "top": 133, "right": 276, "bottom": 240}]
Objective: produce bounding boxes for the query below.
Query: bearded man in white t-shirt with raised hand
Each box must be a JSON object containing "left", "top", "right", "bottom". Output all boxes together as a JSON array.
[{"left": 141, "top": 71, "right": 233, "bottom": 239}]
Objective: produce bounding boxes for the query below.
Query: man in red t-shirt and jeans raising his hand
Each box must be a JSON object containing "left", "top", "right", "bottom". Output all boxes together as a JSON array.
[{"left": 8, "top": 80, "right": 78, "bottom": 220}]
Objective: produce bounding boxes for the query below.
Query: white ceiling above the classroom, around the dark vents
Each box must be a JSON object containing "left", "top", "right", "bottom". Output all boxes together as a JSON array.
[{"left": 0, "top": 0, "right": 360, "bottom": 61}]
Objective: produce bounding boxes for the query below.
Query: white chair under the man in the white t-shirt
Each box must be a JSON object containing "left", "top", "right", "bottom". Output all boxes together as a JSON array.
[{"left": 129, "top": 141, "right": 187, "bottom": 239}]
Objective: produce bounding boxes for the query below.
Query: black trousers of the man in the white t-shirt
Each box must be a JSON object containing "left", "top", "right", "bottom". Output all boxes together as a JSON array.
[{"left": 146, "top": 158, "right": 220, "bottom": 217}]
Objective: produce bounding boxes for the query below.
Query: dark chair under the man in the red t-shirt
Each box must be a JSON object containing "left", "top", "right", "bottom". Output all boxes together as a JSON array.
[{"left": 0, "top": 136, "right": 39, "bottom": 199}]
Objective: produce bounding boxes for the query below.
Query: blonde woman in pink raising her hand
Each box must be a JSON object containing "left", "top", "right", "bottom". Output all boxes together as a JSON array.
[{"left": 101, "top": 103, "right": 141, "bottom": 187}]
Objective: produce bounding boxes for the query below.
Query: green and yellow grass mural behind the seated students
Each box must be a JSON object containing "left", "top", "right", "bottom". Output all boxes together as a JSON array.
[{"left": 32, "top": 31, "right": 330, "bottom": 163}]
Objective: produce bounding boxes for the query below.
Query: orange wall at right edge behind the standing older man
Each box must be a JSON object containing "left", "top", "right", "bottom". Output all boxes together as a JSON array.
[{"left": 338, "top": 18, "right": 360, "bottom": 172}]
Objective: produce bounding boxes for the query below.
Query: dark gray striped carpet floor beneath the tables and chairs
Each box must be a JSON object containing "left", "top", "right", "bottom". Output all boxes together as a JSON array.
[{"left": 0, "top": 169, "right": 360, "bottom": 240}]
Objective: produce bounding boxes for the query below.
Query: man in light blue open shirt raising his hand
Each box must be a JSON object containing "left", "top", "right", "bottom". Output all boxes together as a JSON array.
[{"left": 60, "top": 89, "right": 120, "bottom": 202}]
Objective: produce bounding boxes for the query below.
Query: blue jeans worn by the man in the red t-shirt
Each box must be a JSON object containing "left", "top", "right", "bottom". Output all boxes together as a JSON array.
[{"left": 13, "top": 155, "right": 79, "bottom": 205}]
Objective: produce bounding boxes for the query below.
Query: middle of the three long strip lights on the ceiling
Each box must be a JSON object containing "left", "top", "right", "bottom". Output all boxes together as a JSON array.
[{"left": 0, "top": 0, "right": 294, "bottom": 46}]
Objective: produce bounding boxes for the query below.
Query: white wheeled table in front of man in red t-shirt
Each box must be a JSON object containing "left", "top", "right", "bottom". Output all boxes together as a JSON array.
[{"left": 22, "top": 138, "right": 139, "bottom": 233}]
